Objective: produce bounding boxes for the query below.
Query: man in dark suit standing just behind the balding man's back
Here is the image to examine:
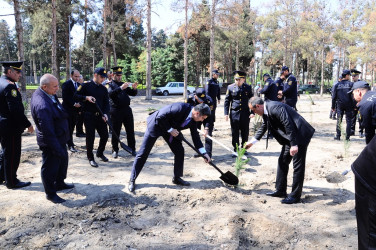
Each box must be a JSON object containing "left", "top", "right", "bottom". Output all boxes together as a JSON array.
[{"left": 61, "top": 70, "right": 81, "bottom": 152}]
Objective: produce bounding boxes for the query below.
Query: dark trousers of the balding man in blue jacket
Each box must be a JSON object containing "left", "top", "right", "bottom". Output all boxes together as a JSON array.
[{"left": 41, "top": 145, "right": 68, "bottom": 196}]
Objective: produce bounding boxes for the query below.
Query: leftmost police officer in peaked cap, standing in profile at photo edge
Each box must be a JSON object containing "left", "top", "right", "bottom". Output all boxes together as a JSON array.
[{"left": 0, "top": 62, "right": 34, "bottom": 189}]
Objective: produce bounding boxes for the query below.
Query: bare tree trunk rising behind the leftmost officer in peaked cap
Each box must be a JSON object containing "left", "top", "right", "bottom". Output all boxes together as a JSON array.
[{"left": 13, "top": 0, "right": 26, "bottom": 92}]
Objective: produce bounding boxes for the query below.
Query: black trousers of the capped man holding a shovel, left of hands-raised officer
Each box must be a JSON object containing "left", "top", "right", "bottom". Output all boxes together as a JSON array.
[{"left": 84, "top": 112, "right": 108, "bottom": 161}]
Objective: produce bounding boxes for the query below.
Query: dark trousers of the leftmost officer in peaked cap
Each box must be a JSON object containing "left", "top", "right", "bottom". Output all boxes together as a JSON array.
[{"left": 0, "top": 133, "right": 21, "bottom": 187}]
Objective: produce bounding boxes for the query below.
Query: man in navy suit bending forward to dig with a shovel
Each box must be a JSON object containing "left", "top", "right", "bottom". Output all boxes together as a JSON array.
[{"left": 128, "top": 103, "right": 210, "bottom": 192}]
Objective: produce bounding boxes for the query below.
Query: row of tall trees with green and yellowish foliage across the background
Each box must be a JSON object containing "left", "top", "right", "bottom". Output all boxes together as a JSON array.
[{"left": 0, "top": 0, "right": 376, "bottom": 96}]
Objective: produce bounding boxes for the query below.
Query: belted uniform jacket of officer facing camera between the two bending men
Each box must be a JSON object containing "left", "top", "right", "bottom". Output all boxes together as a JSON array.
[{"left": 224, "top": 83, "right": 253, "bottom": 120}]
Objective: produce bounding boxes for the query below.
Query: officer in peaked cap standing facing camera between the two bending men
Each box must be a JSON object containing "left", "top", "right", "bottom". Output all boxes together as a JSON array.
[{"left": 224, "top": 71, "right": 253, "bottom": 152}]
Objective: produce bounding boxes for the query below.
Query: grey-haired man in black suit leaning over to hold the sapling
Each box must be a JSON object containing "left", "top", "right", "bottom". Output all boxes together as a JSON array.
[{"left": 246, "top": 97, "right": 315, "bottom": 204}]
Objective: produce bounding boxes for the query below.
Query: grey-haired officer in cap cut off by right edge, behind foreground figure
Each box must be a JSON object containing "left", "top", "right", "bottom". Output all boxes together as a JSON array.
[{"left": 351, "top": 81, "right": 376, "bottom": 144}]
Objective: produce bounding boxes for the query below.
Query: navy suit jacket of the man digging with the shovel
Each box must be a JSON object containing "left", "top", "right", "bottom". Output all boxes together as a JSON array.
[{"left": 147, "top": 102, "right": 203, "bottom": 149}]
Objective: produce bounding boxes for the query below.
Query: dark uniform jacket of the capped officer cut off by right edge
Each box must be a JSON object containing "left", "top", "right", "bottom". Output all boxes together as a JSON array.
[{"left": 358, "top": 91, "right": 376, "bottom": 144}]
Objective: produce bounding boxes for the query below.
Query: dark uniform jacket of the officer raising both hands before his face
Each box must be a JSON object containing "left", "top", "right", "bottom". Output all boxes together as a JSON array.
[{"left": 108, "top": 80, "right": 137, "bottom": 109}]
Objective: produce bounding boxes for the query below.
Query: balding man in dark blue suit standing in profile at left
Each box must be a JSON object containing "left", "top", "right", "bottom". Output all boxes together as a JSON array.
[{"left": 30, "top": 74, "right": 74, "bottom": 203}]
